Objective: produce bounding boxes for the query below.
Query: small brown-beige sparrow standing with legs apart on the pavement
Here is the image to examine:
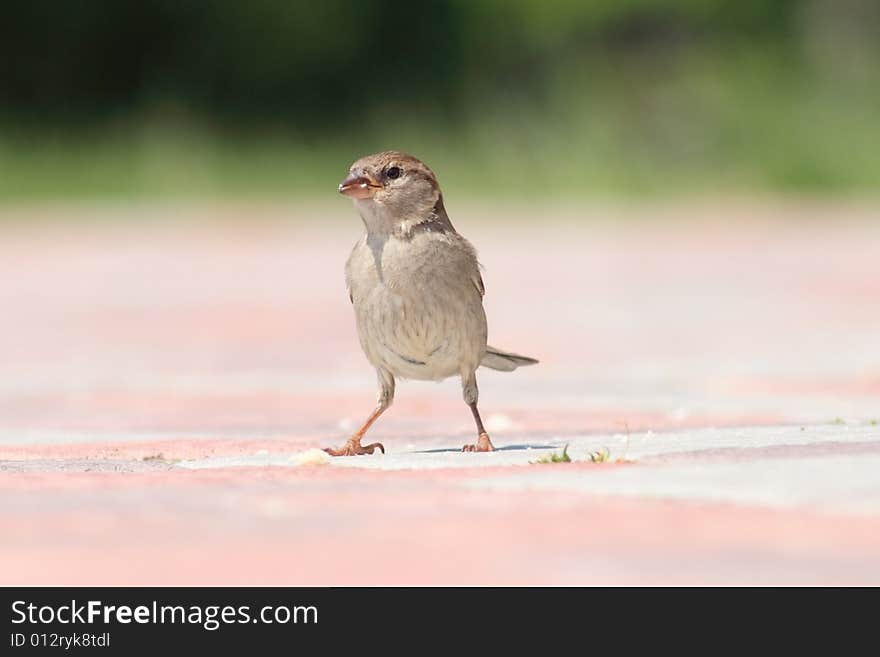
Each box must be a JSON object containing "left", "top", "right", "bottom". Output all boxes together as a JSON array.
[{"left": 324, "top": 151, "right": 538, "bottom": 456}]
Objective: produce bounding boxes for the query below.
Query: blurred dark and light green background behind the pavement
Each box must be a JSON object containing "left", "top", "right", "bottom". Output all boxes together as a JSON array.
[{"left": 0, "top": 0, "right": 880, "bottom": 201}]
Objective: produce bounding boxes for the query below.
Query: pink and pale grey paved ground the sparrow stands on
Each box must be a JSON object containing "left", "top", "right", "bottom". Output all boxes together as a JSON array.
[{"left": 0, "top": 201, "right": 880, "bottom": 585}]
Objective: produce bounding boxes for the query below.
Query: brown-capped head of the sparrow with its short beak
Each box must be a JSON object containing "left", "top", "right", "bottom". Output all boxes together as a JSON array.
[{"left": 339, "top": 151, "right": 440, "bottom": 228}]
